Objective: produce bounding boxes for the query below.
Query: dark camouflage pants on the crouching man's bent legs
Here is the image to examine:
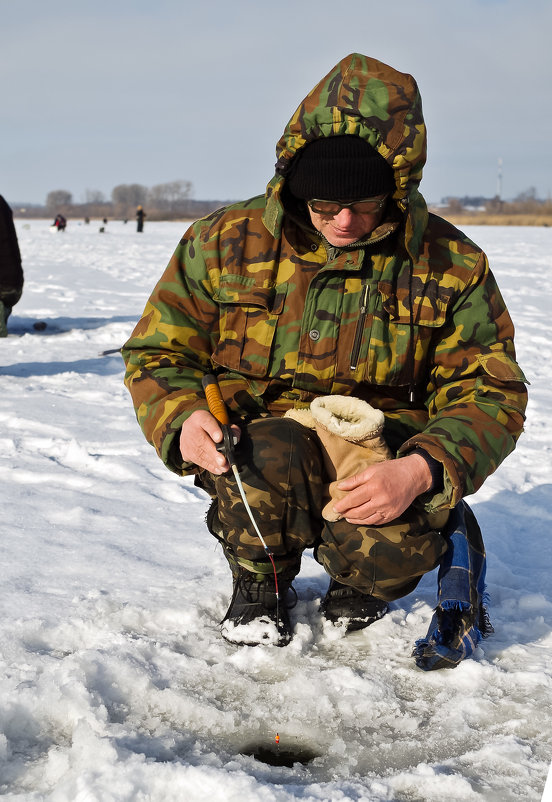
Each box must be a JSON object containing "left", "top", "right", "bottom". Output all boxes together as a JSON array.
[{"left": 196, "top": 418, "right": 446, "bottom": 601}]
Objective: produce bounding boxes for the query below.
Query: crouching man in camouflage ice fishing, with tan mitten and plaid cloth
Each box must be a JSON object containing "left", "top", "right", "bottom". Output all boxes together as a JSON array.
[{"left": 123, "top": 54, "right": 526, "bottom": 670}]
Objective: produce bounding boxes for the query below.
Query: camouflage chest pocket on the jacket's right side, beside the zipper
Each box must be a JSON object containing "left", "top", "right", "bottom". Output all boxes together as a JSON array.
[{"left": 364, "top": 282, "right": 447, "bottom": 386}]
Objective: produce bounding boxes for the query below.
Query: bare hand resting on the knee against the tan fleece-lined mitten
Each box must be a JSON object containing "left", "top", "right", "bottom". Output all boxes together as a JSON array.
[{"left": 334, "top": 454, "right": 431, "bottom": 526}]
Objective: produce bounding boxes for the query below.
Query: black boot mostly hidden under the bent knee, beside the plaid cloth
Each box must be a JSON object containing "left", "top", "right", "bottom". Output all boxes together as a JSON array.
[{"left": 320, "top": 579, "right": 389, "bottom": 632}]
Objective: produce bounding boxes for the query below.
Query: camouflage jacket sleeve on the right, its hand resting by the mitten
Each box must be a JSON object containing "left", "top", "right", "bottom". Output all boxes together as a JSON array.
[{"left": 399, "top": 253, "right": 527, "bottom": 511}]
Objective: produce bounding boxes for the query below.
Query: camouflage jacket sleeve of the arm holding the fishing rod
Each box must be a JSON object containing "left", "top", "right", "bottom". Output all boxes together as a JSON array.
[{"left": 122, "top": 227, "right": 219, "bottom": 474}]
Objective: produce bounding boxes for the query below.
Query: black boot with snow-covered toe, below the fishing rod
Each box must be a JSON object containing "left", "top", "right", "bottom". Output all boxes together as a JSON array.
[{"left": 220, "top": 565, "right": 295, "bottom": 646}]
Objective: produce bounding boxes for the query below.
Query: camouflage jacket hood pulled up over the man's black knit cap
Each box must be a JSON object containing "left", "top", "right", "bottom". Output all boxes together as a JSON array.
[{"left": 263, "top": 53, "right": 428, "bottom": 257}]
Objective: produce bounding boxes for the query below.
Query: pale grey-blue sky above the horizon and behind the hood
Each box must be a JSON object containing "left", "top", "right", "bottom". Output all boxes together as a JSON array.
[{"left": 0, "top": 0, "right": 552, "bottom": 203}]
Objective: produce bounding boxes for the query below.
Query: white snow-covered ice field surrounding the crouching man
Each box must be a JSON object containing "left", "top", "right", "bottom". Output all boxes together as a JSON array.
[{"left": 0, "top": 220, "right": 552, "bottom": 802}]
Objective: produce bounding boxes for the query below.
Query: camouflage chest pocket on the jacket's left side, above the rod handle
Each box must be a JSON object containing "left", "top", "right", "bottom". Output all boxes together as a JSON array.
[{"left": 209, "top": 276, "right": 285, "bottom": 377}]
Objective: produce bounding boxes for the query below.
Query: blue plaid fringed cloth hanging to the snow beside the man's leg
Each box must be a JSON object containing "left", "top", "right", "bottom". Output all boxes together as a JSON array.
[{"left": 412, "top": 501, "right": 493, "bottom": 671}]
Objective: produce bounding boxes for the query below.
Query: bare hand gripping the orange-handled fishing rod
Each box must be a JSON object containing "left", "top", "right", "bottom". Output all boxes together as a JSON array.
[{"left": 180, "top": 409, "right": 240, "bottom": 475}]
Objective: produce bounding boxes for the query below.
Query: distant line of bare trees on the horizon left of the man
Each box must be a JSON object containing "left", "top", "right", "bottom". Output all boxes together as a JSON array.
[{"left": 12, "top": 181, "right": 234, "bottom": 220}]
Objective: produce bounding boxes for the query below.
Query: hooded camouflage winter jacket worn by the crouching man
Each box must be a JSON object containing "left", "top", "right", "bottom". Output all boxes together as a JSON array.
[{"left": 123, "top": 54, "right": 526, "bottom": 510}]
